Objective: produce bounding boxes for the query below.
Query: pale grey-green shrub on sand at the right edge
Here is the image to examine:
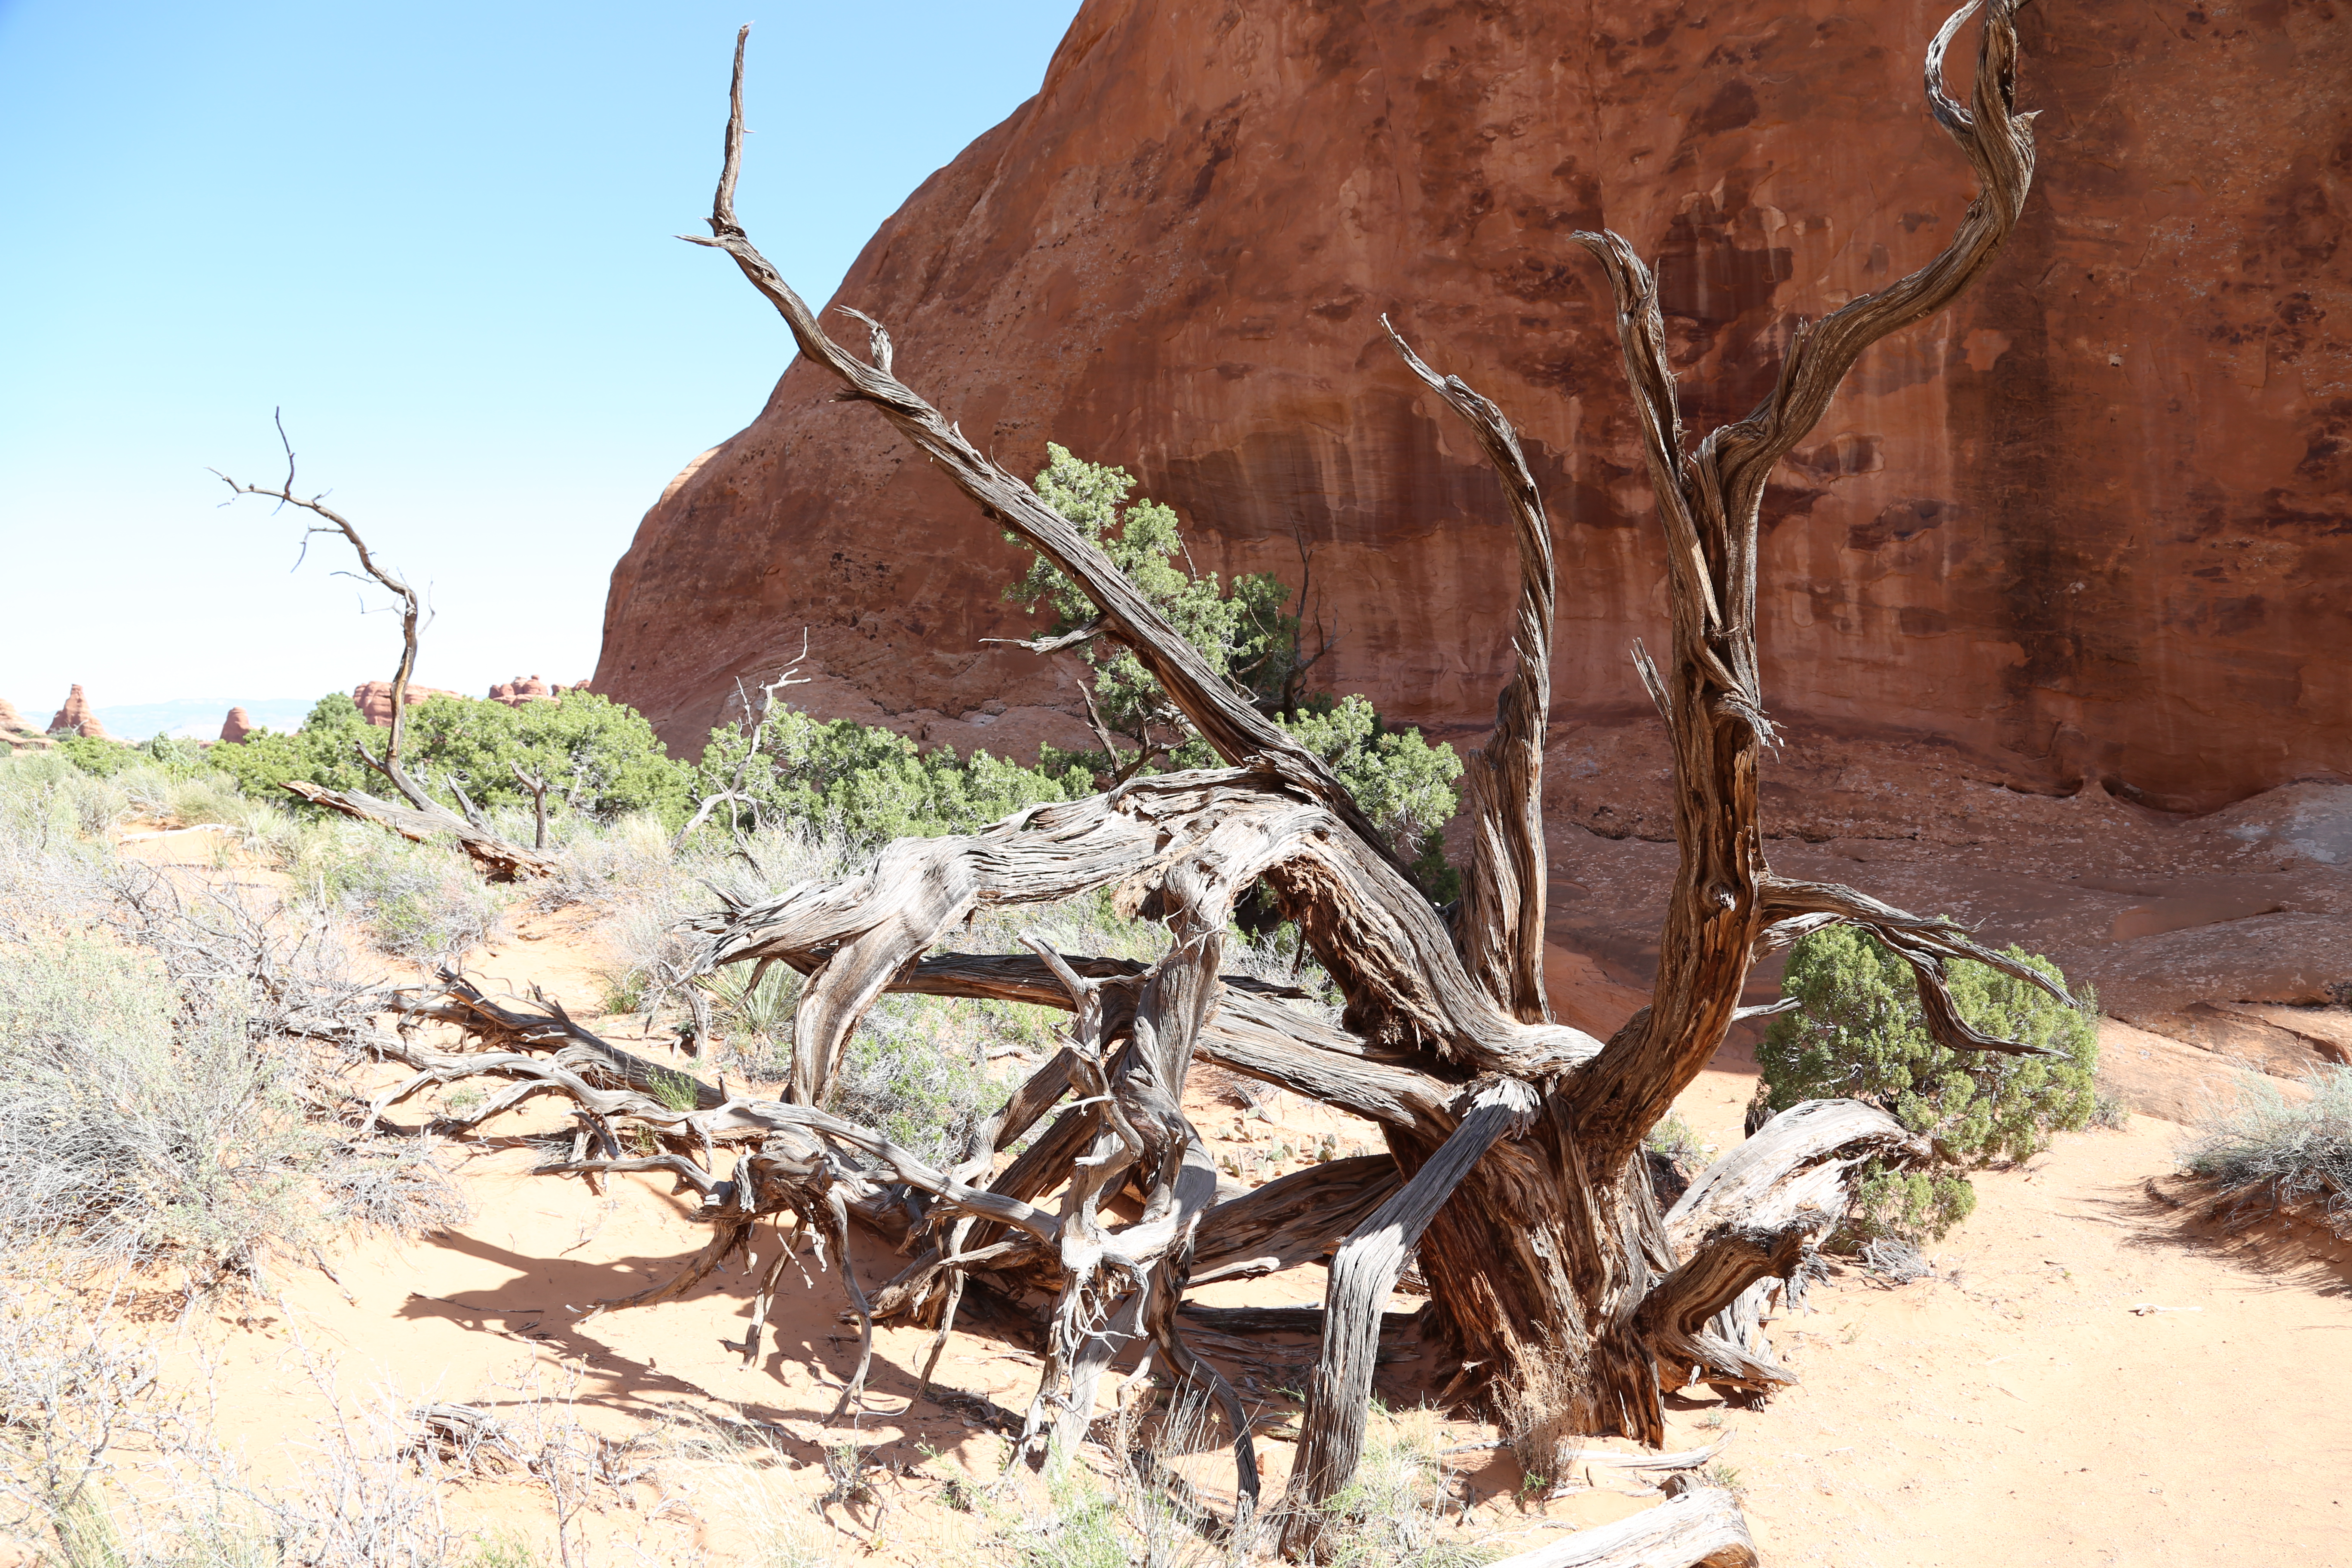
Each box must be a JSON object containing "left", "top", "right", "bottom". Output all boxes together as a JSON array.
[{"left": 2180, "top": 1065, "right": 2352, "bottom": 1237}]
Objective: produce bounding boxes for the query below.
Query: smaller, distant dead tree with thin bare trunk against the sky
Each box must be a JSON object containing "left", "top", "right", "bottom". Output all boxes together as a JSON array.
[{"left": 214, "top": 416, "right": 555, "bottom": 879}]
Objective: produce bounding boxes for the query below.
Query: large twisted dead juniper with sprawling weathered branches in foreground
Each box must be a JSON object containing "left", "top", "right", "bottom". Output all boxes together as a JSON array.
[{"left": 381, "top": 0, "right": 2063, "bottom": 1561}]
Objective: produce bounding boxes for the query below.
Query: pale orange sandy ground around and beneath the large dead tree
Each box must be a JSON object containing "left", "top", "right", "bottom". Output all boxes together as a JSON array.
[{"left": 41, "top": 860, "right": 2352, "bottom": 1568}]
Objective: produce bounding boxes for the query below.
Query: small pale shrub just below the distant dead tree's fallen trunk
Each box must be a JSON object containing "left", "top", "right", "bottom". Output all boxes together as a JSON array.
[{"left": 287, "top": 821, "right": 508, "bottom": 962}]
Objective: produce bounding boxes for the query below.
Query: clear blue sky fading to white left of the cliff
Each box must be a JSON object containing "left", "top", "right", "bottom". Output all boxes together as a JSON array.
[{"left": 0, "top": 0, "right": 1077, "bottom": 722}]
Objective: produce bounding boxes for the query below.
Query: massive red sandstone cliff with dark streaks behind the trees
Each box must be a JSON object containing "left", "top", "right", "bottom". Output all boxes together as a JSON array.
[{"left": 597, "top": 0, "right": 2352, "bottom": 806}]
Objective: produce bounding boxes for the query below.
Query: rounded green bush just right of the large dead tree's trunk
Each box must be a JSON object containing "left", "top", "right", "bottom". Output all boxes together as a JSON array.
[{"left": 1757, "top": 926, "right": 2098, "bottom": 1243}]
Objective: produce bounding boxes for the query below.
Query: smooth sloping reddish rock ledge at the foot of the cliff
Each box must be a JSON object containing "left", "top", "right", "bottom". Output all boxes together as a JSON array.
[{"left": 1543, "top": 724, "right": 2352, "bottom": 1119}]
